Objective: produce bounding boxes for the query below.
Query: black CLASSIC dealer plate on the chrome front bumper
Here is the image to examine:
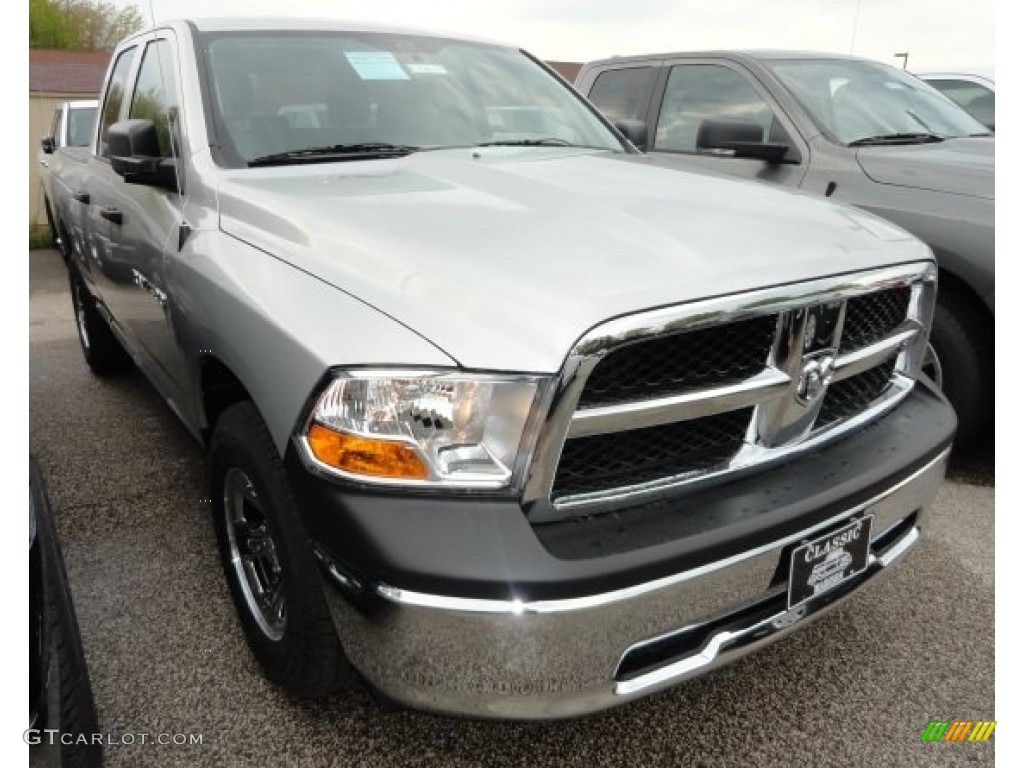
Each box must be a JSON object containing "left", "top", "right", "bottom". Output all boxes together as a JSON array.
[{"left": 790, "top": 515, "right": 872, "bottom": 608}]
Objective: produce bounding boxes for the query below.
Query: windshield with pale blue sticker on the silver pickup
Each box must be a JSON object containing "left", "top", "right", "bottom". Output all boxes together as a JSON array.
[{"left": 199, "top": 32, "right": 624, "bottom": 166}]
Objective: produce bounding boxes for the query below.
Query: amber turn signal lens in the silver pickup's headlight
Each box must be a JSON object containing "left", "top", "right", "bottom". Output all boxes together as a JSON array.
[{"left": 306, "top": 424, "right": 428, "bottom": 480}]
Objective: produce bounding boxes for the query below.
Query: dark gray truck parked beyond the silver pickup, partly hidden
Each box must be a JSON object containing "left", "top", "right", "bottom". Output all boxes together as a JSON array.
[{"left": 577, "top": 51, "right": 995, "bottom": 441}]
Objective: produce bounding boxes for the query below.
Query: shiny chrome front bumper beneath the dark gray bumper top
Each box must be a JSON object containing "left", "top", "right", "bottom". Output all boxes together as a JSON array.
[{"left": 325, "top": 451, "right": 948, "bottom": 719}]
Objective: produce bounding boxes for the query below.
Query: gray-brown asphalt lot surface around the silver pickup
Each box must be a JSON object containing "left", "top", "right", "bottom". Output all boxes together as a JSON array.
[{"left": 30, "top": 252, "right": 995, "bottom": 768}]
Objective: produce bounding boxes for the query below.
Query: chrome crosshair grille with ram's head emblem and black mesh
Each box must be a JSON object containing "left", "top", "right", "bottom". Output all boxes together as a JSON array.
[{"left": 523, "top": 263, "right": 936, "bottom": 522}]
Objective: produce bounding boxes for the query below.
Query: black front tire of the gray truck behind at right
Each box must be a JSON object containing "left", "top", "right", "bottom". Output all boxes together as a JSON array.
[{"left": 931, "top": 288, "right": 995, "bottom": 444}]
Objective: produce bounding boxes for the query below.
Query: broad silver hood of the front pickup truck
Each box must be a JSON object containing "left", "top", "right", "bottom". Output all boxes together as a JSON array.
[{"left": 218, "top": 147, "right": 931, "bottom": 372}]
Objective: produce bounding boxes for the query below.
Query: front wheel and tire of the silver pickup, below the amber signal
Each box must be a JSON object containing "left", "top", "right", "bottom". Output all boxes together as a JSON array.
[{"left": 210, "top": 401, "right": 354, "bottom": 698}]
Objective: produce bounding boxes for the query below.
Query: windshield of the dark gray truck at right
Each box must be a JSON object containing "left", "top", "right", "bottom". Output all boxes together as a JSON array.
[{"left": 765, "top": 59, "right": 990, "bottom": 144}]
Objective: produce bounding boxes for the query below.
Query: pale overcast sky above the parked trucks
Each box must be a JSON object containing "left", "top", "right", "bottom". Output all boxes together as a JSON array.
[{"left": 115, "top": 0, "right": 995, "bottom": 69}]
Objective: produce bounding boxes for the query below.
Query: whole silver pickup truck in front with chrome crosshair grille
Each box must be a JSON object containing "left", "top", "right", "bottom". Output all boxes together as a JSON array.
[{"left": 49, "top": 20, "right": 955, "bottom": 718}]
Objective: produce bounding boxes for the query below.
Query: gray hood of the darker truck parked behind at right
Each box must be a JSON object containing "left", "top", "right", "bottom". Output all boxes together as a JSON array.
[{"left": 857, "top": 137, "right": 995, "bottom": 200}]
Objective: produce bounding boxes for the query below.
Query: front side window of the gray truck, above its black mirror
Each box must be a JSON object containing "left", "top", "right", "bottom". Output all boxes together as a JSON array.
[{"left": 654, "top": 65, "right": 787, "bottom": 152}]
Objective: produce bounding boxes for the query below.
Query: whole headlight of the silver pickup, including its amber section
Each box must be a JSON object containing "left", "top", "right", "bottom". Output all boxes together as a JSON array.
[{"left": 303, "top": 371, "right": 541, "bottom": 488}]
